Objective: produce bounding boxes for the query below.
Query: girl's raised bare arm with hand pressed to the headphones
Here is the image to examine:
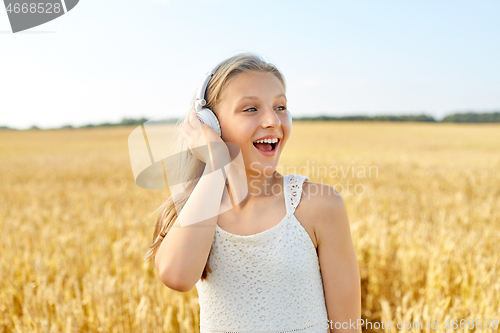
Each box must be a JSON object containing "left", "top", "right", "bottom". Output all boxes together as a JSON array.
[{"left": 155, "top": 110, "right": 234, "bottom": 291}]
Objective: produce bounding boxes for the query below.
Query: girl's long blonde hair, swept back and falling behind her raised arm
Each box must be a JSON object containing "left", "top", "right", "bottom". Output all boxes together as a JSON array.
[{"left": 144, "top": 53, "right": 286, "bottom": 280}]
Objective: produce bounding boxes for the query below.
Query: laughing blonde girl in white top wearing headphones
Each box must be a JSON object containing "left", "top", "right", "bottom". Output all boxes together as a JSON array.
[{"left": 146, "top": 53, "right": 361, "bottom": 333}]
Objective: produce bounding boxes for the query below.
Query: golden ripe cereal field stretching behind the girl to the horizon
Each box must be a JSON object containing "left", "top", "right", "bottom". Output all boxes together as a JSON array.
[{"left": 0, "top": 122, "right": 500, "bottom": 332}]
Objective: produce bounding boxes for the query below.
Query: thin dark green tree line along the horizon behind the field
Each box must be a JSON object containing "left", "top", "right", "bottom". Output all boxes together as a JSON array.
[{"left": 0, "top": 111, "right": 500, "bottom": 130}]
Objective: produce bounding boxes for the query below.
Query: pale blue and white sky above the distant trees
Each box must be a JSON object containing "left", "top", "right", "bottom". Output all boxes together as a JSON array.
[{"left": 0, "top": 0, "right": 500, "bottom": 128}]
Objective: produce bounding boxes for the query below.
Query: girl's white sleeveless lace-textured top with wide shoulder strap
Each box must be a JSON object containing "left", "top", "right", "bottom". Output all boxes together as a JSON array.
[{"left": 196, "top": 175, "right": 328, "bottom": 333}]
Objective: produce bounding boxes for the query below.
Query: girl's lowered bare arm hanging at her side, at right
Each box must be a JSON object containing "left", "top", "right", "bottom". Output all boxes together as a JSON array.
[{"left": 315, "top": 187, "right": 361, "bottom": 333}]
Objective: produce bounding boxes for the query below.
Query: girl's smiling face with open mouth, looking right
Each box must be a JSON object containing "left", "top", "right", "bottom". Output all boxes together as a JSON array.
[{"left": 215, "top": 71, "right": 292, "bottom": 175}]
